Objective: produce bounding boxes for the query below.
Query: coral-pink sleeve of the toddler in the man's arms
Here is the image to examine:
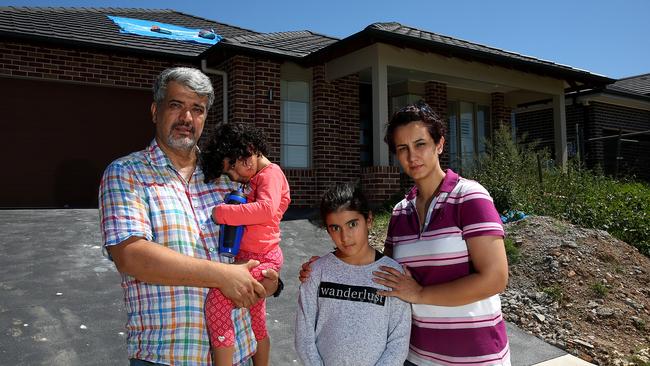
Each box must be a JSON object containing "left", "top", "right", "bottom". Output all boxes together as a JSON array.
[{"left": 212, "top": 167, "right": 286, "bottom": 225}]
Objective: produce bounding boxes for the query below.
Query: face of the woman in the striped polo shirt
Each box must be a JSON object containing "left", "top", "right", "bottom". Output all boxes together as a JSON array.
[{"left": 393, "top": 121, "right": 445, "bottom": 182}]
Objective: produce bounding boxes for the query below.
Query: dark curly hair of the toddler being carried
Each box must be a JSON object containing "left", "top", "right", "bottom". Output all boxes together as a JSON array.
[{"left": 201, "top": 123, "right": 269, "bottom": 183}]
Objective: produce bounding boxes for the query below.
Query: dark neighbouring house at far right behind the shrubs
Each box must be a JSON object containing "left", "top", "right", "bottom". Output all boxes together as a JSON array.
[{"left": 513, "top": 74, "right": 650, "bottom": 181}]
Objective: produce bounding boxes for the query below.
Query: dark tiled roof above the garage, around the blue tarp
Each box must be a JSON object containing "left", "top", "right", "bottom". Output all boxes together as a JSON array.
[{"left": 0, "top": 7, "right": 256, "bottom": 57}]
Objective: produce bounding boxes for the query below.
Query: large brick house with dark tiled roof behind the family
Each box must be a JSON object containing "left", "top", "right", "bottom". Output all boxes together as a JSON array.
[{"left": 0, "top": 8, "right": 613, "bottom": 207}]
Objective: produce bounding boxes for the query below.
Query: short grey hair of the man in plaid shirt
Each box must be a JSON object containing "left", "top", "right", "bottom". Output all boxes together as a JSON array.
[{"left": 153, "top": 67, "right": 214, "bottom": 109}]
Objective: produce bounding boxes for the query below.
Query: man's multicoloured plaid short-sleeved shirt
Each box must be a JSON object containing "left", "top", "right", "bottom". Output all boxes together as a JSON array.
[{"left": 99, "top": 140, "right": 256, "bottom": 366}]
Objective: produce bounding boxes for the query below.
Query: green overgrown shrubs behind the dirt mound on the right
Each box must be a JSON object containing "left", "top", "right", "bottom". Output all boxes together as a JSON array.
[{"left": 468, "top": 126, "right": 650, "bottom": 256}]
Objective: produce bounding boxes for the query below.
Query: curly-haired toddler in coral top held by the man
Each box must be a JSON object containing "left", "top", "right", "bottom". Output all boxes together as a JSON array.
[{"left": 201, "top": 124, "right": 291, "bottom": 366}]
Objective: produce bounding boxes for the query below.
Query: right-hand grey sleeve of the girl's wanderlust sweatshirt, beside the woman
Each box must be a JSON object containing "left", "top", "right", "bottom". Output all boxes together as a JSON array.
[{"left": 375, "top": 280, "right": 411, "bottom": 366}]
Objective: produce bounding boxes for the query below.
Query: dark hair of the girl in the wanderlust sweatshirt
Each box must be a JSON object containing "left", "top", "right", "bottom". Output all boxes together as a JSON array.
[{"left": 320, "top": 183, "right": 370, "bottom": 227}]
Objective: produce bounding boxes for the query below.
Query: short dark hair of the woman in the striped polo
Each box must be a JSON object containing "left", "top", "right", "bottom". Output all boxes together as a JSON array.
[{"left": 384, "top": 100, "right": 447, "bottom": 153}]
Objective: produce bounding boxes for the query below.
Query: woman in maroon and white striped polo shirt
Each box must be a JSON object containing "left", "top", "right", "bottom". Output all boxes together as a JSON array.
[{"left": 301, "top": 102, "right": 510, "bottom": 365}]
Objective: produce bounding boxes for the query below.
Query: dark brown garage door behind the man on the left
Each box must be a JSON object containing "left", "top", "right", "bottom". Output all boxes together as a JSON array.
[{"left": 0, "top": 78, "right": 154, "bottom": 208}]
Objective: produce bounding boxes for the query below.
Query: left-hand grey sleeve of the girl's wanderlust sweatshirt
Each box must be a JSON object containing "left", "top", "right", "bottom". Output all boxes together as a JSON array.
[{"left": 294, "top": 268, "right": 323, "bottom": 366}]
